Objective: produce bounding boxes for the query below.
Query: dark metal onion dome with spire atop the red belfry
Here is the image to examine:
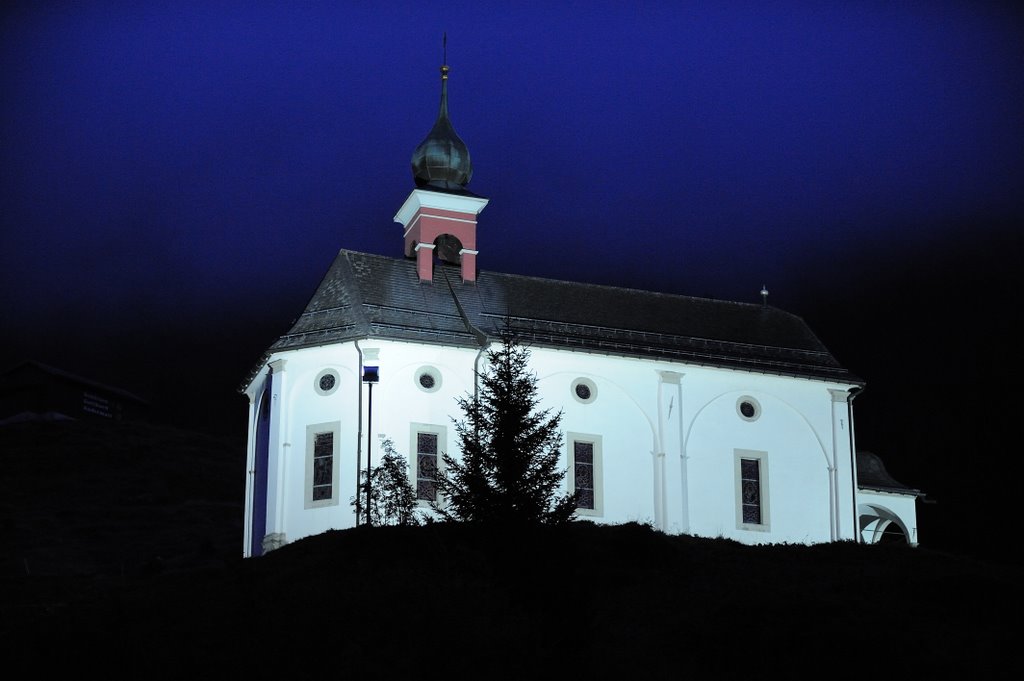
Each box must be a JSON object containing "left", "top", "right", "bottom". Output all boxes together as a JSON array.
[{"left": 413, "top": 66, "right": 473, "bottom": 189}]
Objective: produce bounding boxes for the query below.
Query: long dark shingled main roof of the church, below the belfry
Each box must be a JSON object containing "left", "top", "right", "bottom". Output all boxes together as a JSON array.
[{"left": 243, "top": 250, "right": 862, "bottom": 389}]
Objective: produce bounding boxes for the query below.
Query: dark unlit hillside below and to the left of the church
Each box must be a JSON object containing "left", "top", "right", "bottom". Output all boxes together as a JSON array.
[{"left": 0, "top": 419, "right": 1021, "bottom": 678}]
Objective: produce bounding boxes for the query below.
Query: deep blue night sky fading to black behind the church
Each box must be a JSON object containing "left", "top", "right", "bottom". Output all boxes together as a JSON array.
[{"left": 0, "top": 0, "right": 1024, "bottom": 552}]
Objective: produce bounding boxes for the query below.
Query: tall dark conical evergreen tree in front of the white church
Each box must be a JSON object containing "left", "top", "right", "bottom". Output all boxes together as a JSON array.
[{"left": 432, "top": 327, "right": 577, "bottom": 524}]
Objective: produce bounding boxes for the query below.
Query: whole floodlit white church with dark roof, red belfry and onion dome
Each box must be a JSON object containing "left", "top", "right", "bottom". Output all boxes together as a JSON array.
[{"left": 241, "top": 62, "right": 920, "bottom": 556}]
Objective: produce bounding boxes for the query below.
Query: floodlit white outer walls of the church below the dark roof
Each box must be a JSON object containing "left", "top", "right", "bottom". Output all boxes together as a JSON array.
[{"left": 239, "top": 340, "right": 915, "bottom": 554}]
